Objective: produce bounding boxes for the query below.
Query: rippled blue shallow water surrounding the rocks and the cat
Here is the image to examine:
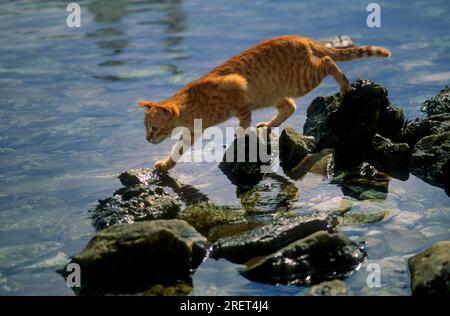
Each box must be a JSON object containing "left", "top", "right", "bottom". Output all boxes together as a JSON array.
[{"left": 0, "top": 0, "right": 450, "bottom": 295}]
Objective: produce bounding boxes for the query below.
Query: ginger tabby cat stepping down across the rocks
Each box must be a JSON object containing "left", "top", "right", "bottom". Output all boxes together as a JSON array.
[{"left": 138, "top": 36, "right": 391, "bottom": 171}]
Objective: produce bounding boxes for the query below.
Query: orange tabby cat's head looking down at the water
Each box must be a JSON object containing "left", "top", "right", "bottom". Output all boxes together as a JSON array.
[{"left": 137, "top": 101, "right": 180, "bottom": 144}]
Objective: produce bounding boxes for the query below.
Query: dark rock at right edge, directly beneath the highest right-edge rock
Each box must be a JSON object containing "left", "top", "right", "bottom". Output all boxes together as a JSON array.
[{"left": 400, "top": 113, "right": 450, "bottom": 148}]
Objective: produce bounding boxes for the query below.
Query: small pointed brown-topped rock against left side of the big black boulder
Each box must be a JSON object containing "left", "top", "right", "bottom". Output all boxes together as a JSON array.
[{"left": 279, "top": 127, "right": 316, "bottom": 169}]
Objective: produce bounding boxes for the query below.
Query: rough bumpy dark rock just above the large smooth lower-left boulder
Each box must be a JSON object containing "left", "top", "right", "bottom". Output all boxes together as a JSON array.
[{"left": 91, "top": 184, "right": 180, "bottom": 230}]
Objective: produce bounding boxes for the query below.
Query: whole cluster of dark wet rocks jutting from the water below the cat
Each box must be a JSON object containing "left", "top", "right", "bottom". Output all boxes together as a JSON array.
[{"left": 61, "top": 79, "right": 450, "bottom": 295}]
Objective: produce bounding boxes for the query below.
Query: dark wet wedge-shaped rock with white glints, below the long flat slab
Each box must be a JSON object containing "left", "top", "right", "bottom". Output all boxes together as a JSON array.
[{"left": 242, "top": 231, "right": 365, "bottom": 285}]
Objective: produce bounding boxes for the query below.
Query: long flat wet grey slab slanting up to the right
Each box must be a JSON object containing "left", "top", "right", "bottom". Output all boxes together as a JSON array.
[{"left": 211, "top": 214, "right": 331, "bottom": 263}]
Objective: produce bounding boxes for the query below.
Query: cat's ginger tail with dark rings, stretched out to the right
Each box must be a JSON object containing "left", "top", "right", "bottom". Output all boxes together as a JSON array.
[{"left": 311, "top": 43, "right": 391, "bottom": 61}]
